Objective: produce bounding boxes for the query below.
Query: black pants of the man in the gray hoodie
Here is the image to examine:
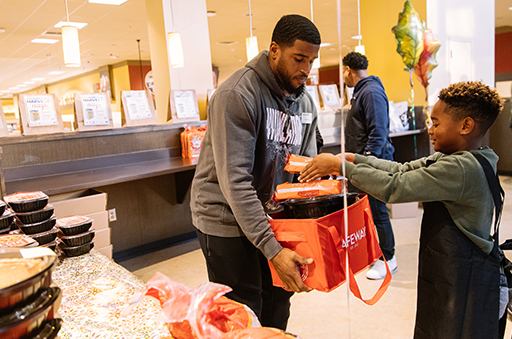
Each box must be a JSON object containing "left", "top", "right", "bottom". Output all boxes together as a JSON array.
[{"left": 196, "top": 230, "right": 293, "bottom": 330}]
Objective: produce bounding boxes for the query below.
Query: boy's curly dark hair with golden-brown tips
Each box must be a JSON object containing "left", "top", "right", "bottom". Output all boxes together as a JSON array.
[{"left": 439, "top": 81, "right": 503, "bottom": 134}]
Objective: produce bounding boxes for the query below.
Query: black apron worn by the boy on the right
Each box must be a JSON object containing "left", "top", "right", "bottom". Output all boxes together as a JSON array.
[{"left": 414, "top": 202, "right": 500, "bottom": 339}]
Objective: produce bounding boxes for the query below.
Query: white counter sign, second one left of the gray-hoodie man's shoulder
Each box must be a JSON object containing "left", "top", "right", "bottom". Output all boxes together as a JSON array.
[{"left": 121, "top": 91, "right": 158, "bottom": 126}]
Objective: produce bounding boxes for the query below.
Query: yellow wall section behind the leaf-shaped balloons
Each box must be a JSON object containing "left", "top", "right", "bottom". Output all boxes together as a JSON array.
[{"left": 360, "top": 0, "right": 428, "bottom": 106}]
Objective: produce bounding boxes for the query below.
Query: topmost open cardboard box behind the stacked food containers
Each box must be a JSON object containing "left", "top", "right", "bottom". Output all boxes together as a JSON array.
[{"left": 48, "top": 189, "right": 107, "bottom": 218}]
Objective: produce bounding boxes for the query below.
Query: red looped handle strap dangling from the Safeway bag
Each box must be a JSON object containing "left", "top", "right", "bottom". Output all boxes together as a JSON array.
[{"left": 328, "top": 209, "right": 391, "bottom": 306}]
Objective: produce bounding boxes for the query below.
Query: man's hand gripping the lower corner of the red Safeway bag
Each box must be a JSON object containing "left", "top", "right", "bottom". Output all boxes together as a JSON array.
[{"left": 270, "top": 248, "right": 313, "bottom": 293}]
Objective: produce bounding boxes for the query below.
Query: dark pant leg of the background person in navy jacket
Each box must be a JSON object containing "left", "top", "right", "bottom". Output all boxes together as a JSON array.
[{"left": 368, "top": 195, "right": 395, "bottom": 260}]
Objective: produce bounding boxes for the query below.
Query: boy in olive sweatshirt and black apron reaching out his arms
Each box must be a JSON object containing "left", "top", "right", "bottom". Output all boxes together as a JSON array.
[{"left": 299, "top": 81, "right": 503, "bottom": 339}]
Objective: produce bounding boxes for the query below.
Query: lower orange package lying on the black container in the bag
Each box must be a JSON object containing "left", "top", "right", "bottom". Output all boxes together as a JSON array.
[{"left": 273, "top": 180, "right": 344, "bottom": 201}]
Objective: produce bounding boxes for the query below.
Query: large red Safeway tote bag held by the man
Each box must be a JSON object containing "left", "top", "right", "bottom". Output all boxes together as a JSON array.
[{"left": 269, "top": 194, "right": 391, "bottom": 305}]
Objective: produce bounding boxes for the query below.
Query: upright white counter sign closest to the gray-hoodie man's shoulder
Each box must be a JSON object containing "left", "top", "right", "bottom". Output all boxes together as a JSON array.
[{"left": 169, "top": 89, "right": 199, "bottom": 122}]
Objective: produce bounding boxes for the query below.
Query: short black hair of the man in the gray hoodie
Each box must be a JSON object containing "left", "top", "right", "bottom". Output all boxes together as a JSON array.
[{"left": 272, "top": 14, "right": 322, "bottom": 47}]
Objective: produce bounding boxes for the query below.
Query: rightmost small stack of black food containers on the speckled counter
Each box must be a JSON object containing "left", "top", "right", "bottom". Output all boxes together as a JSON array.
[{"left": 57, "top": 215, "right": 94, "bottom": 257}]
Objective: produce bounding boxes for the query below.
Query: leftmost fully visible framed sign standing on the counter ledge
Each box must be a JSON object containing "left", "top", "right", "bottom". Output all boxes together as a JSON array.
[{"left": 19, "top": 94, "right": 64, "bottom": 135}]
